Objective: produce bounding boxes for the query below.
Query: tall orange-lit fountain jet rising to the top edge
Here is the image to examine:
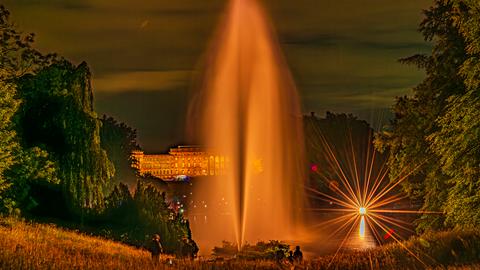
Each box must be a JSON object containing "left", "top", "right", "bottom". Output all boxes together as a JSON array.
[{"left": 188, "top": 0, "right": 304, "bottom": 250}]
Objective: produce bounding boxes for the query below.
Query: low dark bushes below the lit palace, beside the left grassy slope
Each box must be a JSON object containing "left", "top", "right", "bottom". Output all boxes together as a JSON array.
[{"left": 100, "top": 181, "right": 191, "bottom": 255}]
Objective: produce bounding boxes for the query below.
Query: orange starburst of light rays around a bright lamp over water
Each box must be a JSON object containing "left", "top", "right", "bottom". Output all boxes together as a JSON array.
[{"left": 307, "top": 120, "right": 441, "bottom": 263}]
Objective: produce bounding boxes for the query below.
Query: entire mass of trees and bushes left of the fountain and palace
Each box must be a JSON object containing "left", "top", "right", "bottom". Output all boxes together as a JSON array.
[{"left": 0, "top": 3, "right": 195, "bottom": 253}]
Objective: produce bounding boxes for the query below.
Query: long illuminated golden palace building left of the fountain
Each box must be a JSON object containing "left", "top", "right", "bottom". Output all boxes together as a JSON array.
[{"left": 132, "top": 146, "right": 226, "bottom": 181}]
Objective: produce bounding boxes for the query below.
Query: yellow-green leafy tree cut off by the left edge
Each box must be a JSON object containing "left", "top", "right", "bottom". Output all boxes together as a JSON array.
[{"left": 0, "top": 5, "right": 59, "bottom": 215}]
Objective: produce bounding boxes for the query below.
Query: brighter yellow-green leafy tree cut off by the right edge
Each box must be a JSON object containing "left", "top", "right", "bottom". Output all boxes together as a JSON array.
[{"left": 428, "top": 1, "right": 480, "bottom": 227}]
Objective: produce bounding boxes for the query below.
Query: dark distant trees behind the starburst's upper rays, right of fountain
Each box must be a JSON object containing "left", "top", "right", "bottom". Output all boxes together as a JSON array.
[{"left": 304, "top": 112, "right": 385, "bottom": 196}]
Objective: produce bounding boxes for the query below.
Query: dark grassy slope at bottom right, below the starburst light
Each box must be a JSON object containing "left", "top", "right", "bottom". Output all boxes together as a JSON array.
[{"left": 311, "top": 230, "right": 480, "bottom": 269}]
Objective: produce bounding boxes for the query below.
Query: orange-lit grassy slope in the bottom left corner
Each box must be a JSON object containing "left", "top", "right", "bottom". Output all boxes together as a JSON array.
[{"left": 0, "top": 219, "right": 151, "bottom": 269}]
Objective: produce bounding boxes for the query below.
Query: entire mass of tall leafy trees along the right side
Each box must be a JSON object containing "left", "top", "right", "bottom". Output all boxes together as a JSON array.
[{"left": 377, "top": 0, "right": 480, "bottom": 230}]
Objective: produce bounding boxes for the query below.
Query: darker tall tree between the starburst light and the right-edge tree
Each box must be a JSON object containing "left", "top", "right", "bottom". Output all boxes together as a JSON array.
[{"left": 376, "top": 0, "right": 467, "bottom": 230}]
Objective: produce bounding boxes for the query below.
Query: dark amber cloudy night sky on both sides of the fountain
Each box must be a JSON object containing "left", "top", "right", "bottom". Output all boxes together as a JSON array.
[{"left": 0, "top": 0, "right": 432, "bottom": 152}]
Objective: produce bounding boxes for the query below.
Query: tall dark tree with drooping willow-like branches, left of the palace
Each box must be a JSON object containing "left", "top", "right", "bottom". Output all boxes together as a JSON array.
[{"left": 18, "top": 61, "right": 114, "bottom": 217}]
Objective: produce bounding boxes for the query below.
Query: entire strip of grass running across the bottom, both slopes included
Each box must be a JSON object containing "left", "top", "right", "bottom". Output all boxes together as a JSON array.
[{"left": 0, "top": 219, "right": 480, "bottom": 269}]
